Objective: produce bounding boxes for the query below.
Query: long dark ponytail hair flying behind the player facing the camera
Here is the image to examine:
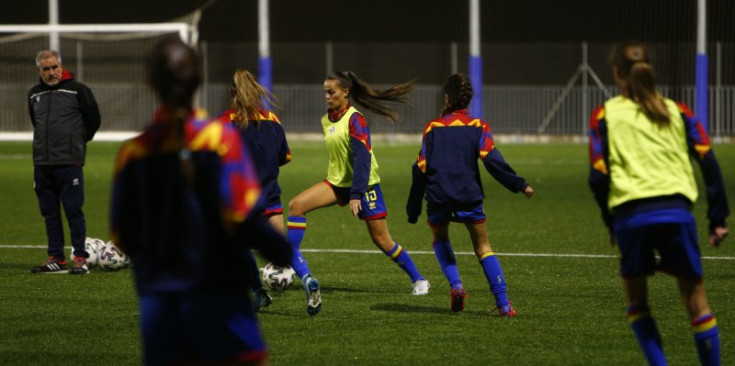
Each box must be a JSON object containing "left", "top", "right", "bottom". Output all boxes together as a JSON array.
[{"left": 326, "top": 71, "right": 415, "bottom": 122}]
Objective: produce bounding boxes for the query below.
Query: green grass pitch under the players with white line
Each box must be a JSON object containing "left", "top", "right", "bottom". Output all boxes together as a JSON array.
[{"left": 0, "top": 142, "right": 735, "bottom": 365}]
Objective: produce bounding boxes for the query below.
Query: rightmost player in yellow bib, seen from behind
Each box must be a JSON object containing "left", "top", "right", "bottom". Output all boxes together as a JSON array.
[{"left": 589, "top": 42, "right": 729, "bottom": 365}]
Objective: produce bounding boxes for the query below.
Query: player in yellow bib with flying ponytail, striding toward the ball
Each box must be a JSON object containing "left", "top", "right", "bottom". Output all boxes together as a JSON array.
[{"left": 287, "top": 71, "right": 429, "bottom": 315}]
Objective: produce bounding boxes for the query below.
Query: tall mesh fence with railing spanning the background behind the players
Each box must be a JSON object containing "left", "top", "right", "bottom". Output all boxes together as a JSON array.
[{"left": 0, "top": 34, "right": 735, "bottom": 137}]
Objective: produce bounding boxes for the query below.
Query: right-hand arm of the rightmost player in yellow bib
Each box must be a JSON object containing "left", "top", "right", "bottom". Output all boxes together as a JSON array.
[{"left": 679, "top": 104, "right": 730, "bottom": 245}]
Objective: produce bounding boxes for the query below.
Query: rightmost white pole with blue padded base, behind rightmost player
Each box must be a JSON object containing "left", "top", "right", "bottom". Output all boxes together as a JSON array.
[{"left": 694, "top": 0, "right": 709, "bottom": 131}]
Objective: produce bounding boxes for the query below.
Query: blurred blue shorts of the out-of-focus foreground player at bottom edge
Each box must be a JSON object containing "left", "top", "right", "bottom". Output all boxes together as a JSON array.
[{"left": 140, "top": 291, "right": 268, "bottom": 365}]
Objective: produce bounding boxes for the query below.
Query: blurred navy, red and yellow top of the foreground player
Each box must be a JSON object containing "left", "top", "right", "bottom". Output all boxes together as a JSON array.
[{"left": 110, "top": 110, "right": 290, "bottom": 294}]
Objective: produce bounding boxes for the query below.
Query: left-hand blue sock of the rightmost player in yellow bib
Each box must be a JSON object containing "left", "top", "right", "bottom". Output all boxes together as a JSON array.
[{"left": 628, "top": 305, "right": 666, "bottom": 365}]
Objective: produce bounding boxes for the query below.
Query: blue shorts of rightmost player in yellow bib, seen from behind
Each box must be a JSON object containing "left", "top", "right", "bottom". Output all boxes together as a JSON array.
[{"left": 613, "top": 209, "right": 702, "bottom": 279}]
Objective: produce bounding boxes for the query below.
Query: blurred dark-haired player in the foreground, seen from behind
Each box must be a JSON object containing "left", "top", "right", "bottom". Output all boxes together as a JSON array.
[{"left": 110, "top": 38, "right": 291, "bottom": 365}]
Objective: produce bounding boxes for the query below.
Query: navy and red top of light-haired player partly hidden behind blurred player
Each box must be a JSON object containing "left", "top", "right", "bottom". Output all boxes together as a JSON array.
[{"left": 219, "top": 109, "right": 291, "bottom": 205}]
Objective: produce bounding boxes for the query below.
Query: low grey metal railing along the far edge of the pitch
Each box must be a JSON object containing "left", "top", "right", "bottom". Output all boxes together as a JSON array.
[{"left": 0, "top": 82, "right": 735, "bottom": 137}]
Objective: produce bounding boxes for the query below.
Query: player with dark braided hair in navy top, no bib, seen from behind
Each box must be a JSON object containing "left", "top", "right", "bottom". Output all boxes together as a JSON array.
[{"left": 406, "top": 74, "right": 533, "bottom": 317}]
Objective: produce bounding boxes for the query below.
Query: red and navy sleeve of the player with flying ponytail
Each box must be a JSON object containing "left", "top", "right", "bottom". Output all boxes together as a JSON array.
[{"left": 350, "top": 113, "right": 372, "bottom": 199}]
